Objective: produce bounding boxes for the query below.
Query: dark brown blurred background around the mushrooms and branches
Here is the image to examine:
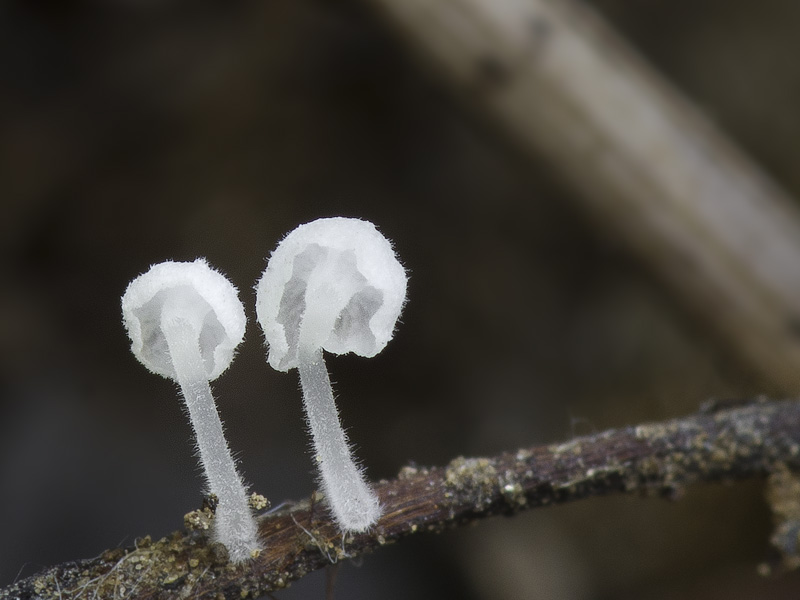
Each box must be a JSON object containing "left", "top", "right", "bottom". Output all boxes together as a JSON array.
[{"left": 0, "top": 0, "right": 800, "bottom": 600}]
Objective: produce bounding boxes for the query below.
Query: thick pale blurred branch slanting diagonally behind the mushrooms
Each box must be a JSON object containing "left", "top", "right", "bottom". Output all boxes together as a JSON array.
[{"left": 362, "top": 0, "right": 800, "bottom": 391}]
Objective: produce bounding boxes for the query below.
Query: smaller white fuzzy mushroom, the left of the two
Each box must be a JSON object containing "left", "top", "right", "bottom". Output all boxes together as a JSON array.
[{"left": 122, "top": 259, "right": 261, "bottom": 562}]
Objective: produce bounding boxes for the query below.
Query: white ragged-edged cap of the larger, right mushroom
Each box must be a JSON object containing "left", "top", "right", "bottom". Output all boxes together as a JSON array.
[{"left": 256, "top": 217, "right": 407, "bottom": 371}]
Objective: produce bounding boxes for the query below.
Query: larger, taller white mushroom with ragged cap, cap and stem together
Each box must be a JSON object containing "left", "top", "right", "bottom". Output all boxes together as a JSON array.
[{"left": 256, "top": 217, "right": 406, "bottom": 532}]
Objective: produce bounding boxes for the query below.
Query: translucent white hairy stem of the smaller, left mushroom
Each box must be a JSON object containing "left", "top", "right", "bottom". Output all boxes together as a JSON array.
[{"left": 161, "top": 310, "right": 260, "bottom": 562}]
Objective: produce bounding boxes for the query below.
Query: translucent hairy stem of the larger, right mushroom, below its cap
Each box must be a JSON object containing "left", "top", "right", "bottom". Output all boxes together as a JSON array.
[{"left": 297, "top": 349, "right": 381, "bottom": 531}]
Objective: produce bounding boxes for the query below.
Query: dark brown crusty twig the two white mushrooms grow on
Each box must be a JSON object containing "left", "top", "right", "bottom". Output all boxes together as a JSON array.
[{"left": 6, "top": 400, "right": 800, "bottom": 600}]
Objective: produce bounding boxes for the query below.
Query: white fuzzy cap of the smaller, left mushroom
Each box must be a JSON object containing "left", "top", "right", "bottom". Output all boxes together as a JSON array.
[{"left": 122, "top": 258, "right": 246, "bottom": 380}]
